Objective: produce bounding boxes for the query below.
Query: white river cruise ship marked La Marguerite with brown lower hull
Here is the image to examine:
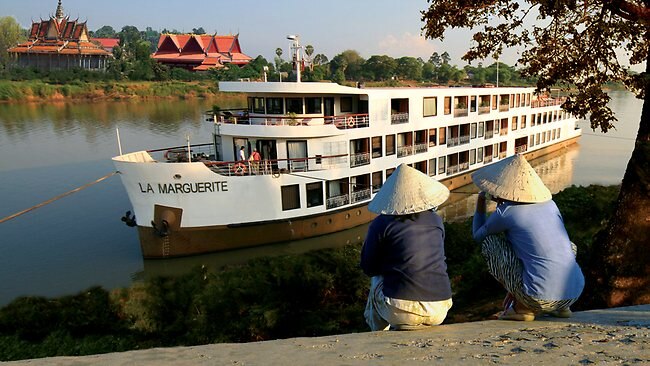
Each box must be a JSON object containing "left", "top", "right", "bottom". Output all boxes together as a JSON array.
[{"left": 113, "top": 81, "right": 581, "bottom": 258}]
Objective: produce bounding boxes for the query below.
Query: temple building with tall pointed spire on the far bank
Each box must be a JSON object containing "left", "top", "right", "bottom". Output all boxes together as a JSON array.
[{"left": 7, "top": 0, "right": 113, "bottom": 70}]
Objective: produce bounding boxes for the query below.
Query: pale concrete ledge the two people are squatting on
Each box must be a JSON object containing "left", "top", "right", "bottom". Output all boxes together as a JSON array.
[{"left": 9, "top": 305, "right": 650, "bottom": 365}]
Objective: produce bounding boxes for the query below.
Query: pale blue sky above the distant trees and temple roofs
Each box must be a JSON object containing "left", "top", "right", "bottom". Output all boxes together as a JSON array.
[{"left": 0, "top": 0, "right": 506, "bottom": 66}]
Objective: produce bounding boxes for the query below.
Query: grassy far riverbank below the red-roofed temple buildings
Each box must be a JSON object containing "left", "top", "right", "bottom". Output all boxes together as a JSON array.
[{"left": 0, "top": 80, "right": 241, "bottom": 103}]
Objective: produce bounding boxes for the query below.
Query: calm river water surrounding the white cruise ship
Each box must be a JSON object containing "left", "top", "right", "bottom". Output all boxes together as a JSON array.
[{"left": 0, "top": 92, "right": 642, "bottom": 306}]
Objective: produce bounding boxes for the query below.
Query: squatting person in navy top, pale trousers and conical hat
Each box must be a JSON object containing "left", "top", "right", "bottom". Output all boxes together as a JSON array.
[{"left": 361, "top": 164, "right": 452, "bottom": 331}]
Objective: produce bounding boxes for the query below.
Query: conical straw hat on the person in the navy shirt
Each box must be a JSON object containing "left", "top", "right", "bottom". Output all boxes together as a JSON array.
[{"left": 368, "top": 164, "right": 449, "bottom": 215}]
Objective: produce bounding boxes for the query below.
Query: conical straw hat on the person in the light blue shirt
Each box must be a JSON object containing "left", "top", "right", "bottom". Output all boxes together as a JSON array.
[{"left": 472, "top": 154, "right": 551, "bottom": 203}]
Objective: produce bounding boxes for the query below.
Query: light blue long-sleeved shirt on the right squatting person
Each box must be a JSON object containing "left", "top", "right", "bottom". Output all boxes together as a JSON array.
[{"left": 473, "top": 200, "right": 585, "bottom": 301}]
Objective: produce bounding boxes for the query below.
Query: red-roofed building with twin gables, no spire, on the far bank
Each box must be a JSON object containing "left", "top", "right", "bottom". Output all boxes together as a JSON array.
[{"left": 152, "top": 34, "right": 252, "bottom": 71}]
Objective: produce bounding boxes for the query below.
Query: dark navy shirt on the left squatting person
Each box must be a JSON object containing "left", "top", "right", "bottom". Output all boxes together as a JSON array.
[{"left": 361, "top": 211, "right": 451, "bottom": 301}]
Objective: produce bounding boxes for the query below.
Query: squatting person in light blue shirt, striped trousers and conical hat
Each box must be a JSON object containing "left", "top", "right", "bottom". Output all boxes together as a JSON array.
[{"left": 472, "top": 154, "right": 584, "bottom": 321}]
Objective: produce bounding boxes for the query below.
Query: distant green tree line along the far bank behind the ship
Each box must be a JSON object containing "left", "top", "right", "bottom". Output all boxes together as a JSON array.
[{"left": 0, "top": 17, "right": 534, "bottom": 85}]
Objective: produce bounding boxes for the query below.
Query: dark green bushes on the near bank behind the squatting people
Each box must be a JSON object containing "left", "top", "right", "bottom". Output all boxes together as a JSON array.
[{"left": 0, "top": 185, "right": 620, "bottom": 361}]
